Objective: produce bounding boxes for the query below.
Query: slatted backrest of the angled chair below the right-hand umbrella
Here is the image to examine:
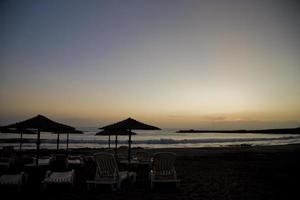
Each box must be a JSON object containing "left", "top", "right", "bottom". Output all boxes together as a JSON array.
[{"left": 94, "top": 152, "right": 119, "bottom": 180}]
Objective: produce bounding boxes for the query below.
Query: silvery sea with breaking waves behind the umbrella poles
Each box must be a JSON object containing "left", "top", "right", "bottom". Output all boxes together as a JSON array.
[{"left": 0, "top": 127, "right": 300, "bottom": 149}]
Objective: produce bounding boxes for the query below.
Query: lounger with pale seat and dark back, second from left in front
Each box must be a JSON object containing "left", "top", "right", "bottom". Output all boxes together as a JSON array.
[{"left": 43, "top": 154, "right": 75, "bottom": 188}]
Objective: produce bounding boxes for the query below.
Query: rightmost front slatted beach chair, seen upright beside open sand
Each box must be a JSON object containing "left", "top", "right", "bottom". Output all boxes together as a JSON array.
[{"left": 150, "top": 152, "right": 180, "bottom": 188}]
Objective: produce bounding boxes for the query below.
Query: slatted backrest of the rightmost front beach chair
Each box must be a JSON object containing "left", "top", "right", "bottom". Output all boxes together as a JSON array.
[{"left": 152, "top": 152, "right": 176, "bottom": 176}]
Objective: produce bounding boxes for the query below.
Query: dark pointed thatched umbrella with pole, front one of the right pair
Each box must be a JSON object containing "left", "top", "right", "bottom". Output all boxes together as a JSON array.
[{"left": 100, "top": 118, "right": 160, "bottom": 161}]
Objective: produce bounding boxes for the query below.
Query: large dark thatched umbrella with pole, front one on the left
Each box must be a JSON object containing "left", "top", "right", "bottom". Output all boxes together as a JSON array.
[{"left": 5, "top": 115, "right": 75, "bottom": 165}]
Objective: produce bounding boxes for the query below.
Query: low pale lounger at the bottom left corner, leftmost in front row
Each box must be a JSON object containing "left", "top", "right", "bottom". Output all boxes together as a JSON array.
[{"left": 0, "top": 172, "right": 27, "bottom": 191}]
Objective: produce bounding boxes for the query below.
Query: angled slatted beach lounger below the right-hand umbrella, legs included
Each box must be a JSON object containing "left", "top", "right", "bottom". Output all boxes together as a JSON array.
[{"left": 86, "top": 152, "right": 136, "bottom": 190}]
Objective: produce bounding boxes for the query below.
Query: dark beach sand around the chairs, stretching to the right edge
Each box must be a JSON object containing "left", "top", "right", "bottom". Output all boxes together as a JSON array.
[{"left": 0, "top": 145, "right": 300, "bottom": 200}]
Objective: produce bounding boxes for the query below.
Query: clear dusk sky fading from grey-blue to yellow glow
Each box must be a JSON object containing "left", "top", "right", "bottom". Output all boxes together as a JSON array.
[{"left": 0, "top": 0, "right": 300, "bottom": 129}]
